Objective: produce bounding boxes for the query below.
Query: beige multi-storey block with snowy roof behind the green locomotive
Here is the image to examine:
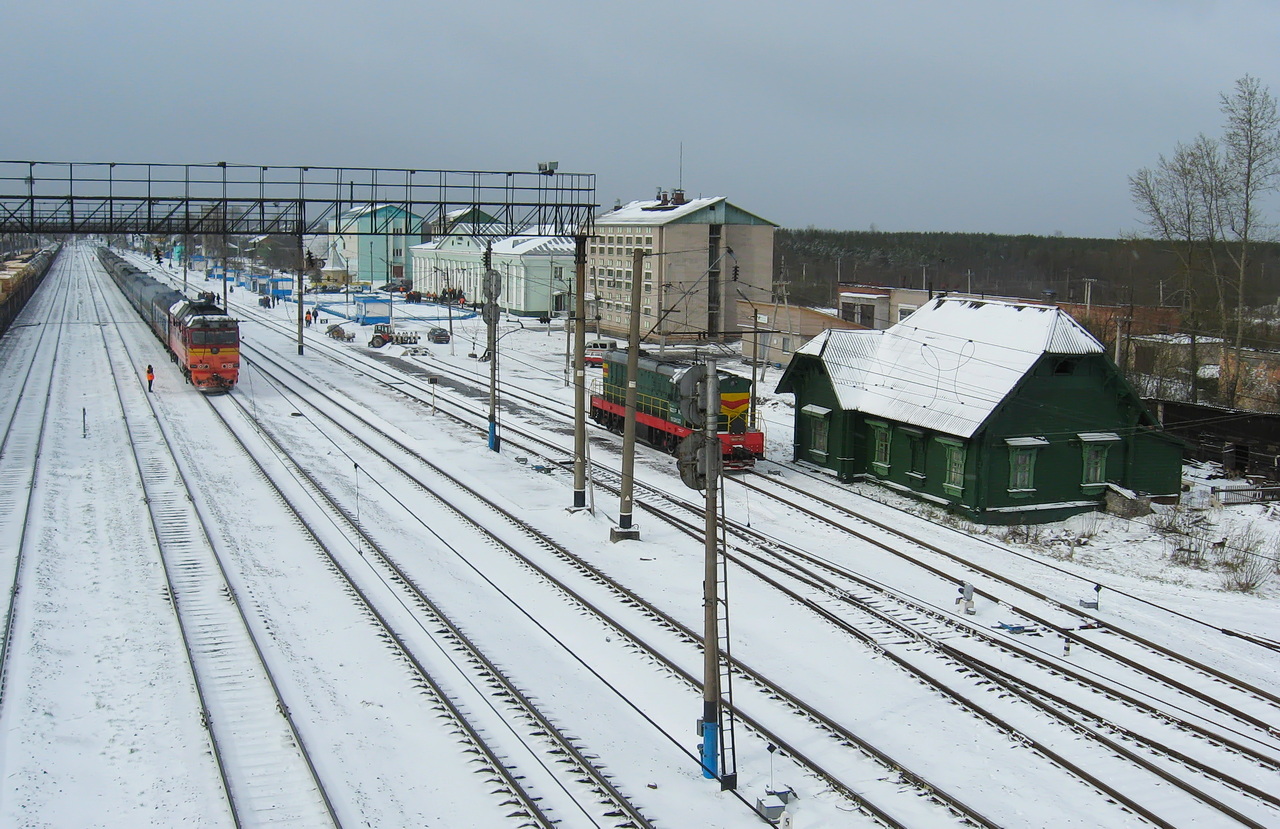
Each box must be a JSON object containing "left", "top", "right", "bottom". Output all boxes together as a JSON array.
[{"left": 586, "top": 189, "right": 777, "bottom": 342}]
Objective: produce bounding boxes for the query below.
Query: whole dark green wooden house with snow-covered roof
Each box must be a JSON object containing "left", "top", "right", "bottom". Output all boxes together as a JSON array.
[{"left": 777, "top": 297, "right": 1181, "bottom": 523}]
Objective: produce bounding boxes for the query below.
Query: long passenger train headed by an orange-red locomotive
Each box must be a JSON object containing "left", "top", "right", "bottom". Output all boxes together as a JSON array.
[{"left": 97, "top": 248, "right": 239, "bottom": 394}]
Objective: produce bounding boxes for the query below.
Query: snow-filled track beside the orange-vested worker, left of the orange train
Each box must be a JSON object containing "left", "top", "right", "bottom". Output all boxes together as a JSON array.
[{"left": 90, "top": 254, "right": 342, "bottom": 826}]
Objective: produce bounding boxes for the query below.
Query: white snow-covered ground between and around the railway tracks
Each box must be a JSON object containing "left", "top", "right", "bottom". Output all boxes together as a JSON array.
[{"left": 0, "top": 248, "right": 1280, "bottom": 828}]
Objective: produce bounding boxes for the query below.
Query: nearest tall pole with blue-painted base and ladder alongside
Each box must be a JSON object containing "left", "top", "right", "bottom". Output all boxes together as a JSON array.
[{"left": 701, "top": 358, "right": 721, "bottom": 779}]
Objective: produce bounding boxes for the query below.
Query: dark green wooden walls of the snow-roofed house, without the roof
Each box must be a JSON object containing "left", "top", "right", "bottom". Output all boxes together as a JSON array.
[{"left": 778, "top": 354, "right": 1181, "bottom": 523}]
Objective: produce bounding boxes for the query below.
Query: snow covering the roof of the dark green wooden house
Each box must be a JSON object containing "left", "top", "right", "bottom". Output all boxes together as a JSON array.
[{"left": 796, "top": 297, "right": 1103, "bottom": 438}]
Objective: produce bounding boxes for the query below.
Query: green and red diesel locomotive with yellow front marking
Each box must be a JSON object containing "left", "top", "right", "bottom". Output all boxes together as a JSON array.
[{"left": 591, "top": 349, "right": 764, "bottom": 470}]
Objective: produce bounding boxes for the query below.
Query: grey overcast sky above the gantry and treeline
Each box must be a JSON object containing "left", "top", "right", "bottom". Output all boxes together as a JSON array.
[{"left": 0, "top": 0, "right": 1280, "bottom": 237}]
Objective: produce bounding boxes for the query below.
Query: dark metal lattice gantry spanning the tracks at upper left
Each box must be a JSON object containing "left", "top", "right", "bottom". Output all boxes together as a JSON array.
[{"left": 0, "top": 161, "right": 598, "bottom": 238}]
